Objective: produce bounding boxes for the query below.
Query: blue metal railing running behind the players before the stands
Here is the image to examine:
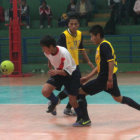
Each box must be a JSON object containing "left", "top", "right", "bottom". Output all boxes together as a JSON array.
[{"left": 0, "top": 34, "right": 140, "bottom": 64}]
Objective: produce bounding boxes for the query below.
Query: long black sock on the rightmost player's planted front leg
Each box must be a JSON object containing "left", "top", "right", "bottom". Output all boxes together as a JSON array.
[{"left": 78, "top": 95, "right": 90, "bottom": 121}]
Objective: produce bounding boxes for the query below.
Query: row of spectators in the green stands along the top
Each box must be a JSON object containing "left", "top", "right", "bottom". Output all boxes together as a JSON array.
[{"left": 0, "top": 0, "right": 140, "bottom": 29}]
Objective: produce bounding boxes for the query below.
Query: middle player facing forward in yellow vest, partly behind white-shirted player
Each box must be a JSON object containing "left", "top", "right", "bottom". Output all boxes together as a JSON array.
[{"left": 47, "top": 16, "right": 94, "bottom": 115}]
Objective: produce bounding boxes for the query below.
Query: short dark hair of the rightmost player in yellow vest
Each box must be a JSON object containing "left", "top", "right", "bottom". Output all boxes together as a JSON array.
[{"left": 89, "top": 25, "right": 104, "bottom": 38}]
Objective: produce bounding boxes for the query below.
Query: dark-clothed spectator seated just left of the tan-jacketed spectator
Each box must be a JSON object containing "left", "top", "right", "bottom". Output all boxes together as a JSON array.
[{"left": 66, "top": 0, "right": 76, "bottom": 16}]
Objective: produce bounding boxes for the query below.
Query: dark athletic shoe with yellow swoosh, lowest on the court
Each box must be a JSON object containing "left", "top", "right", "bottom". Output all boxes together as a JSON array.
[{"left": 72, "top": 119, "right": 91, "bottom": 127}]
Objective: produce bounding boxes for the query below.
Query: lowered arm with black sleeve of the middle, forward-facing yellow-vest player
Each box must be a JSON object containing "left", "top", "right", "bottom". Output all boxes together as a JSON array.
[{"left": 79, "top": 37, "right": 94, "bottom": 69}]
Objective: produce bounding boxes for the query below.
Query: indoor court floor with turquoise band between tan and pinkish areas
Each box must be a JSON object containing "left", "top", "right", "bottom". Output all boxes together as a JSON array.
[{"left": 0, "top": 73, "right": 140, "bottom": 140}]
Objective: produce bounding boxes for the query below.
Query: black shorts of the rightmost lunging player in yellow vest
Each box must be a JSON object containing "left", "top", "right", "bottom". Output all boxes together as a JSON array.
[{"left": 82, "top": 74, "right": 121, "bottom": 97}]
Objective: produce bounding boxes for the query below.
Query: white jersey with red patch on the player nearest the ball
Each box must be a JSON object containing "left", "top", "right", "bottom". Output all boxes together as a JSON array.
[{"left": 44, "top": 46, "right": 76, "bottom": 75}]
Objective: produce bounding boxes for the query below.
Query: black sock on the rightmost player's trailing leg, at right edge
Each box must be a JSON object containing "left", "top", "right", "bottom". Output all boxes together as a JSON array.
[{"left": 122, "top": 96, "right": 140, "bottom": 110}]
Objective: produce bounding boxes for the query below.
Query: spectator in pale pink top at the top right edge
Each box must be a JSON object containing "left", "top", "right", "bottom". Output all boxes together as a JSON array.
[{"left": 133, "top": 0, "right": 140, "bottom": 24}]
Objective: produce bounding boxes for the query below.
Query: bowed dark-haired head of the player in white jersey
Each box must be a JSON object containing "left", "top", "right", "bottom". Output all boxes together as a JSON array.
[{"left": 40, "top": 35, "right": 56, "bottom": 54}]
